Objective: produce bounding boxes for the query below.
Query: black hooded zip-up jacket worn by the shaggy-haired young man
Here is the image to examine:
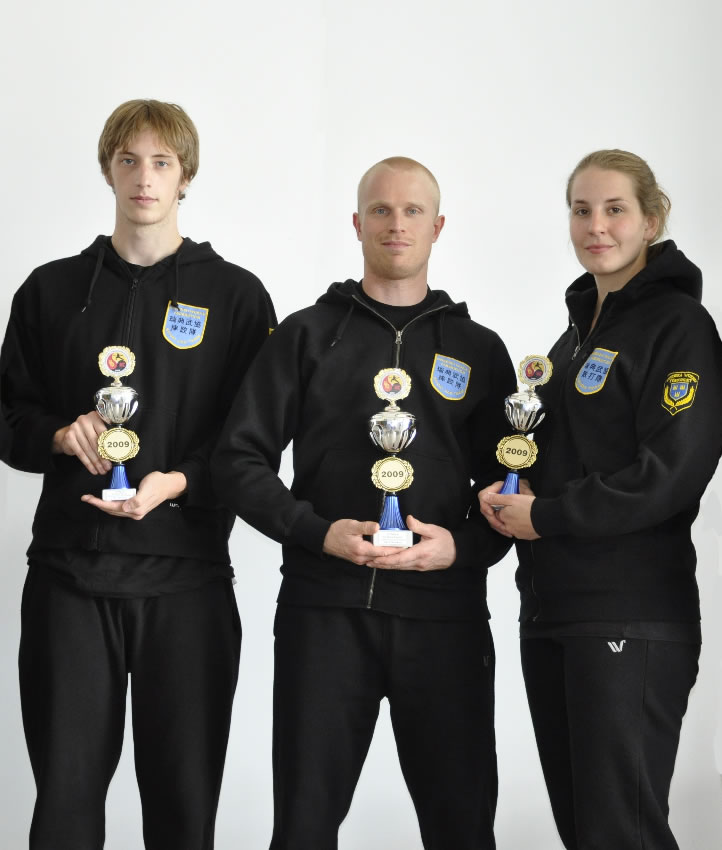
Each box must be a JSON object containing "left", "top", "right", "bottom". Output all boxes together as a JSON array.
[{"left": 0, "top": 236, "right": 274, "bottom": 563}]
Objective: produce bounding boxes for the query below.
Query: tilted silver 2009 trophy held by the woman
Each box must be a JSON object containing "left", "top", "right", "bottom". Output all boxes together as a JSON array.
[{"left": 492, "top": 354, "right": 552, "bottom": 510}]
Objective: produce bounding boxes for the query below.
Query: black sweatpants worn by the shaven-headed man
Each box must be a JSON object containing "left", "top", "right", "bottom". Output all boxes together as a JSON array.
[{"left": 271, "top": 605, "right": 497, "bottom": 850}]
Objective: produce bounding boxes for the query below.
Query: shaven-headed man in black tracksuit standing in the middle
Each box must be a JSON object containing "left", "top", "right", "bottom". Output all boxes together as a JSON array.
[{"left": 213, "top": 157, "right": 516, "bottom": 850}]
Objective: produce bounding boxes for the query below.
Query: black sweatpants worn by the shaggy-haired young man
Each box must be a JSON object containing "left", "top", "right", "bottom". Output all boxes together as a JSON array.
[{"left": 20, "top": 567, "right": 241, "bottom": 850}]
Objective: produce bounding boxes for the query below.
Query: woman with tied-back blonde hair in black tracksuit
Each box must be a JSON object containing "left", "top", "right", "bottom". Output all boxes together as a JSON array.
[{"left": 480, "top": 150, "right": 722, "bottom": 850}]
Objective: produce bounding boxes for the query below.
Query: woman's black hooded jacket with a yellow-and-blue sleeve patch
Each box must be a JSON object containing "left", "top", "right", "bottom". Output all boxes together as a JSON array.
[{"left": 517, "top": 241, "right": 722, "bottom": 622}]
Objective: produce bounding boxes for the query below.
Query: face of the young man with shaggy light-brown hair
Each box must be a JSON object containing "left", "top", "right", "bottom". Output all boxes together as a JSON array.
[{"left": 105, "top": 130, "right": 188, "bottom": 226}]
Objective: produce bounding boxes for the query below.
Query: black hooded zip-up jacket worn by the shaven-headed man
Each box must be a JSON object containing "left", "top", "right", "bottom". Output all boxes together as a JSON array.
[{"left": 212, "top": 280, "right": 515, "bottom": 618}]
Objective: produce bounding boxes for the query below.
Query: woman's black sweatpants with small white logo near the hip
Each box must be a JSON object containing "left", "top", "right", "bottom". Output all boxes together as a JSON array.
[{"left": 521, "top": 636, "right": 700, "bottom": 850}]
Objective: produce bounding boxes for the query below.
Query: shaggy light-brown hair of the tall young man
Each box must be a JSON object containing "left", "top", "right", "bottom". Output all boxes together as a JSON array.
[{"left": 98, "top": 100, "right": 199, "bottom": 200}]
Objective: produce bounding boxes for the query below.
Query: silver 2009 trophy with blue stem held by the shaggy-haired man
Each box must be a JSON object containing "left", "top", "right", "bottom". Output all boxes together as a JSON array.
[{"left": 95, "top": 345, "right": 140, "bottom": 502}]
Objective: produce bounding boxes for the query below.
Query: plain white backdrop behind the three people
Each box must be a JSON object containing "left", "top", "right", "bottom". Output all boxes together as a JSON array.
[{"left": 0, "top": 0, "right": 722, "bottom": 850}]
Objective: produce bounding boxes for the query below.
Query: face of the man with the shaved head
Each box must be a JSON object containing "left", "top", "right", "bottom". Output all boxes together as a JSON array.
[{"left": 353, "top": 166, "right": 444, "bottom": 280}]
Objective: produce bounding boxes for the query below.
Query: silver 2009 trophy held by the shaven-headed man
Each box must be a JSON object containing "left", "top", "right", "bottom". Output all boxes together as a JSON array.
[{"left": 368, "top": 369, "right": 416, "bottom": 549}]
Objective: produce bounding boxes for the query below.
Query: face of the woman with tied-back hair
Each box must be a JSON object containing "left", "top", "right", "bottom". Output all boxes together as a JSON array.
[{"left": 569, "top": 166, "right": 658, "bottom": 291}]
